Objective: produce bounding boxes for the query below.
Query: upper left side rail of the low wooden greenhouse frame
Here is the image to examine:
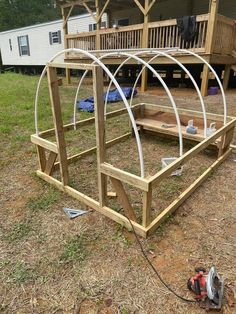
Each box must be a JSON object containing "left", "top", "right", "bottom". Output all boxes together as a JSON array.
[{"left": 39, "top": 105, "right": 140, "bottom": 138}]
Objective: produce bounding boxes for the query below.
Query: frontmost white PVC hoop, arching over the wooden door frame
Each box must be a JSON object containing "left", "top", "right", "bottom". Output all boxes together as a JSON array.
[{"left": 35, "top": 48, "right": 145, "bottom": 178}]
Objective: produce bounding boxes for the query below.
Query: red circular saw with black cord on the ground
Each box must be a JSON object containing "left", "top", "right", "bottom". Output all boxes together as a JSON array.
[{"left": 187, "top": 266, "right": 224, "bottom": 310}]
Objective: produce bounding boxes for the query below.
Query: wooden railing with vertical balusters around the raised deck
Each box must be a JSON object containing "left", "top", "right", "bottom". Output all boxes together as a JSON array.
[{"left": 66, "top": 14, "right": 236, "bottom": 57}]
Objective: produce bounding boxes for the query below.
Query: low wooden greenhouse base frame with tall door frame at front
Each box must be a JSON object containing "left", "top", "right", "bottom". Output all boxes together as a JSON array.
[{"left": 31, "top": 63, "right": 236, "bottom": 237}]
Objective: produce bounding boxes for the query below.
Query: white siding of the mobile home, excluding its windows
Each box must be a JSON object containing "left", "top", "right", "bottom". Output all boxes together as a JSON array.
[{"left": 0, "top": 14, "right": 106, "bottom": 65}]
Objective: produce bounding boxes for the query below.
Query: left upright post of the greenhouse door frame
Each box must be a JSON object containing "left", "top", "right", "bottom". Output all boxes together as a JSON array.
[{"left": 47, "top": 67, "right": 69, "bottom": 185}]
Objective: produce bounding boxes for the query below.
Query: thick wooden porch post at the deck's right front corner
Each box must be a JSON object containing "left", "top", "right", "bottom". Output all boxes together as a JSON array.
[{"left": 201, "top": 0, "right": 219, "bottom": 96}]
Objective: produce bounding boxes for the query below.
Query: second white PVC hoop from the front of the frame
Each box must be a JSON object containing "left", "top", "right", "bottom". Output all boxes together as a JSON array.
[{"left": 74, "top": 52, "right": 183, "bottom": 156}]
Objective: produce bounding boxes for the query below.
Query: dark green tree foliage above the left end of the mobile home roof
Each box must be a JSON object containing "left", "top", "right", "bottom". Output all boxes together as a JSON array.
[{"left": 0, "top": 0, "right": 61, "bottom": 31}]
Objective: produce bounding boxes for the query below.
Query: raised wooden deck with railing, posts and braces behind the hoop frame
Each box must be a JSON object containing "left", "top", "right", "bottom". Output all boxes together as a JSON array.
[{"left": 58, "top": 0, "right": 236, "bottom": 96}]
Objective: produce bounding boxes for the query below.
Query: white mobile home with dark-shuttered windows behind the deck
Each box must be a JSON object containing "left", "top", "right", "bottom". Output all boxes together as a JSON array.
[{"left": 0, "top": 14, "right": 106, "bottom": 68}]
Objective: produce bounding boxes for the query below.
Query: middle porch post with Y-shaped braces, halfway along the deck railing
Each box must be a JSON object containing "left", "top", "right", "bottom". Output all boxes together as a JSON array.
[{"left": 141, "top": 0, "right": 149, "bottom": 92}]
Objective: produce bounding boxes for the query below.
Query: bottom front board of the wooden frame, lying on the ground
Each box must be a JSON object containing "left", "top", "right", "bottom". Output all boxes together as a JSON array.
[{"left": 37, "top": 170, "right": 146, "bottom": 238}]
